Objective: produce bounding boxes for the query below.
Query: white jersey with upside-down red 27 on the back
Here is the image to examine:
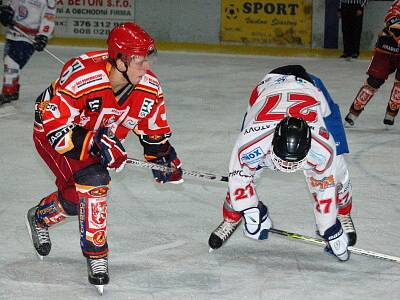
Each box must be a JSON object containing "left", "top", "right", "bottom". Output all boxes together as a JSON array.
[{"left": 229, "top": 74, "right": 338, "bottom": 231}]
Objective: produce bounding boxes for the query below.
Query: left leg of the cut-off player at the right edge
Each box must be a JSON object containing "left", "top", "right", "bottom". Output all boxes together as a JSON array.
[{"left": 345, "top": 52, "right": 395, "bottom": 126}]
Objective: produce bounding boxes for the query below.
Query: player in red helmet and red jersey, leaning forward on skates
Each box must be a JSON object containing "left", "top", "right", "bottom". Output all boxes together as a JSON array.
[{"left": 27, "top": 23, "right": 183, "bottom": 292}]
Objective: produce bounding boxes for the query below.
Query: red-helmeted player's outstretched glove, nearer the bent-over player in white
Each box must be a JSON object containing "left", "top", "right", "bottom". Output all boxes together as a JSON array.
[{"left": 145, "top": 145, "right": 183, "bottom": 184}]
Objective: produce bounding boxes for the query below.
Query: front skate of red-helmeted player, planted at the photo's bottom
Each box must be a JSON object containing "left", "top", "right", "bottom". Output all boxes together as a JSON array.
[{"left": 87, "top": 257, "right": 110, "bottom": 295}]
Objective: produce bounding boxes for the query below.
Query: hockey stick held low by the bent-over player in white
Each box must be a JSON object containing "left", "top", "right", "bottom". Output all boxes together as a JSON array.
[{"left": 269, "top": 228, "right": 400, "bottom": 263}]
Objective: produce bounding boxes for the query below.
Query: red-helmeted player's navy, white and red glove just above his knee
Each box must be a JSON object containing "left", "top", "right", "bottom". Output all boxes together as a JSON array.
[{"left": 94, "top": 127, "right": 128, "bottom": 172}]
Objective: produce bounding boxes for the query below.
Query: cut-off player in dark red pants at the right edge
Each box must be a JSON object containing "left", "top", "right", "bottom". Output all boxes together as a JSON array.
[{"left": 345, "top": 1, "right": 400, "bottom": 126}]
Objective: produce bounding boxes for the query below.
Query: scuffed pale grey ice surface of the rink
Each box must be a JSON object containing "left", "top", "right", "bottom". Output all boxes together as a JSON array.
[{"left": 0, "top": 47, "right": 400, "bottom": 300}]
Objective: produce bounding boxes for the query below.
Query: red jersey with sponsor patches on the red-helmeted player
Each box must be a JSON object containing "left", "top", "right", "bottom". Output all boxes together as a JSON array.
[{"left": 35, "top": 51, "right": 171, "bottom": 160}]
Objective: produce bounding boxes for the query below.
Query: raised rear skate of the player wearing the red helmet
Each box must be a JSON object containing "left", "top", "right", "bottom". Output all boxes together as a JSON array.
[{"left": 26, "top": 206, "right": 51, "bottom": 260}]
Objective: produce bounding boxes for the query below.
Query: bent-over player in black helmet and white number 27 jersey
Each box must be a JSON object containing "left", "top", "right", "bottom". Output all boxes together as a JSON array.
[{"left": 209, "top": 66, "right": 356, "bottom": 261}]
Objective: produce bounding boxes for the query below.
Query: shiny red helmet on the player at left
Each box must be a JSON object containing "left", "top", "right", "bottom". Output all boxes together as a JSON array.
[{"left": 107, "top": 23, "right": 155, "bottom": 59}]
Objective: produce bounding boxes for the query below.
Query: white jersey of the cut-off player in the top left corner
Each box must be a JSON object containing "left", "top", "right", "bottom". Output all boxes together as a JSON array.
[{"left": 6, "top": 0, "right": 56, "bottom": 44}]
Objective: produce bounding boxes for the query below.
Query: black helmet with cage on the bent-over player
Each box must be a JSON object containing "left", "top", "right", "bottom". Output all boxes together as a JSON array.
[{"left": 271, "top": 117, "right": 311, "bottom": 172}]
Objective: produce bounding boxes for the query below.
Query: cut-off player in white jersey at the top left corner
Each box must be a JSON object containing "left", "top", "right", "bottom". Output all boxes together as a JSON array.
[{"left": 0, "top": 0, "right": 56, "bottom": 105}]
